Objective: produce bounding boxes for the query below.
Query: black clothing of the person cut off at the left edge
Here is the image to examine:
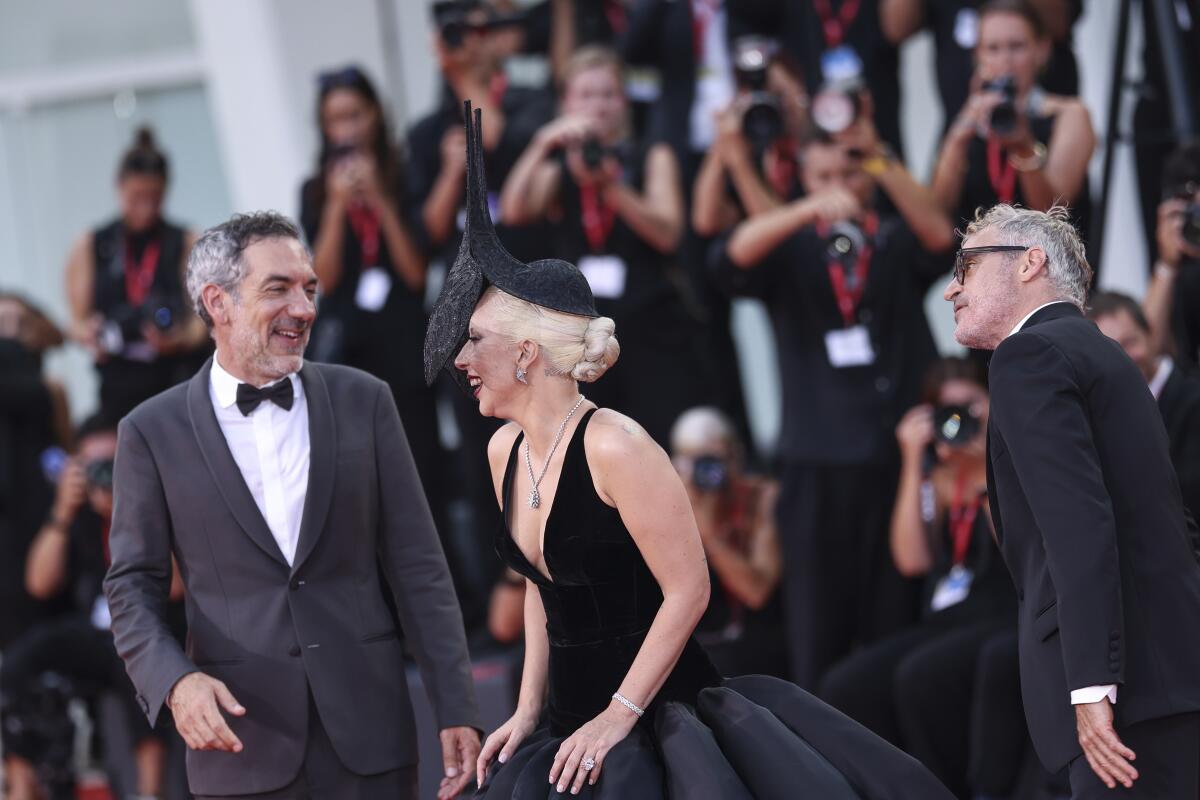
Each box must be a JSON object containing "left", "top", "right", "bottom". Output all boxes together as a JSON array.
[{"left": 0, "top": 338, "right": 56, "bottom": 651}]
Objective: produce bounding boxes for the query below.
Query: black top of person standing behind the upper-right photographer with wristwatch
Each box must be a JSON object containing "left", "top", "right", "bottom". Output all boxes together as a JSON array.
[{"left": 926, "top": 0, "right": 1084, "bottom": 130}]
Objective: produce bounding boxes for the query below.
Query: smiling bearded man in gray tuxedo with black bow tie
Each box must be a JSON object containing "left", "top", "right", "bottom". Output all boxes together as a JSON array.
[{"left": 104, "top": 212, "right": 480, "bottom": 800}]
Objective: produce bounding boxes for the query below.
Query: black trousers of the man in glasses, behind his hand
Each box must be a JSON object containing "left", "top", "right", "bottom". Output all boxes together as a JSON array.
[{"left": 1069, "top": 714, "right": 1200, "bottom": 800}]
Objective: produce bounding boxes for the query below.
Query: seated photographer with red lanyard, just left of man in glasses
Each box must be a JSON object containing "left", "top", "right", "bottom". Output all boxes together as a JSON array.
[{"left": 821, "top": 359, "right": 1016, "bottom": 798}]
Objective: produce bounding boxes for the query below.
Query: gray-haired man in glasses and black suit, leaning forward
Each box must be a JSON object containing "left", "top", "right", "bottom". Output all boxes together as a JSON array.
[{"left": 946, "top": 205, "right": 1200, "bottom": 800}]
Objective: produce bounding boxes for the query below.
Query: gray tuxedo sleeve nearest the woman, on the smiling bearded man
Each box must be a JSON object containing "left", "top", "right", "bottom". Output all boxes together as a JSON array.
[{"left": 374, "top": 383, "right": 479, "bottom": 729}]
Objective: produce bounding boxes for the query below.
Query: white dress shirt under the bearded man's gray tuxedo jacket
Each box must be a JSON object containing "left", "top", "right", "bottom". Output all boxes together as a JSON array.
[{"left": 209, "top": 354, "right": 308, "bottom": 566}]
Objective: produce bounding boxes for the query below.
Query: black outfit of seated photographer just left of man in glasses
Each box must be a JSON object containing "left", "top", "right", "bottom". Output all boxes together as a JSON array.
[{"left": 820, "top": 479, "right": 1016, "bottom": 796}]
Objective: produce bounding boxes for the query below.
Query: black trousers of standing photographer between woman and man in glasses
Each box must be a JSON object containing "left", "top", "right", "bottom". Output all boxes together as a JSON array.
[{"left": 778, "top": 464, "right": 920, "bottom": 692}]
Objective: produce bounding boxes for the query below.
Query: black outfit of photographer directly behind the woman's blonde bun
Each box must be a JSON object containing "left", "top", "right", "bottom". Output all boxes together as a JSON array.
[{"left": 552, "top": 145, "right": 715, "bottom": 447}]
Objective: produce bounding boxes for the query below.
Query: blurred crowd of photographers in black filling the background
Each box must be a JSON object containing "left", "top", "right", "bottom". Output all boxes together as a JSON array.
[{"left": 0, "top": 0, "right": 1200, "bottom": 800}]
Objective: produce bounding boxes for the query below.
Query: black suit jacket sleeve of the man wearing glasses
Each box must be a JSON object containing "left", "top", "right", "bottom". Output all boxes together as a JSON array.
[{"left": 991, "top": 332, "right": 1124, "bottom": 691}]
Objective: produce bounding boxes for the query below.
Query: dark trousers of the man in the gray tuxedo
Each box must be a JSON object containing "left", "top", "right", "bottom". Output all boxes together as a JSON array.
[{"left": 196, "top": 696, "right": 418, "bottom": 800}]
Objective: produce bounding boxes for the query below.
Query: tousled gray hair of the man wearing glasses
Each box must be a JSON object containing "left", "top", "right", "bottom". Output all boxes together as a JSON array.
[{"left": 965, "top": 203, "right": 1092, "bottom": 308}]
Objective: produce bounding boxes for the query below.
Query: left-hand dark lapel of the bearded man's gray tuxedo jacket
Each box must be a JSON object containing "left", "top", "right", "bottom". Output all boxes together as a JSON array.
[{"left": 187, "top": 357, "right": 288, "bottom": 566}]
